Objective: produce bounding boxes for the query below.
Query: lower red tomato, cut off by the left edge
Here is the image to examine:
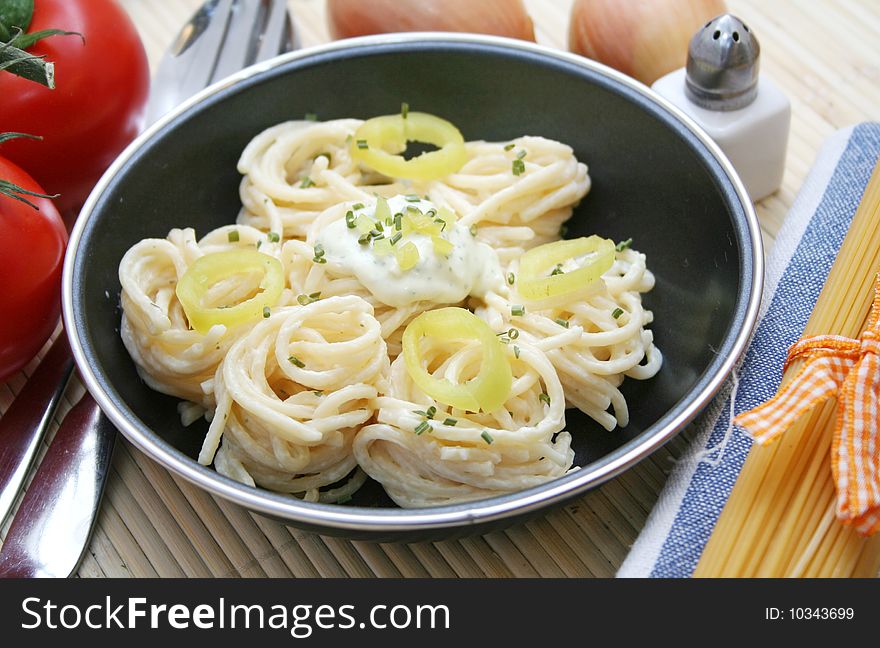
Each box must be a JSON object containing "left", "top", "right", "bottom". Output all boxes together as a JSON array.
[{"left": 0, "top": 154, "right": 67, "bottom": 382}]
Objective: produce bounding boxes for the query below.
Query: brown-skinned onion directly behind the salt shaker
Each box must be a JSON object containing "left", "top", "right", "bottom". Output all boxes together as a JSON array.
[{"left": 568, "top": 0, "right": 727, "bottom": 85}]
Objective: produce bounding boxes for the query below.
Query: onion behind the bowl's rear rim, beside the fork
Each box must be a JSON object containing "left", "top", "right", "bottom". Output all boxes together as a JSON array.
[{"left": 327, "top": 0, "right": 535, "bottom": 42}]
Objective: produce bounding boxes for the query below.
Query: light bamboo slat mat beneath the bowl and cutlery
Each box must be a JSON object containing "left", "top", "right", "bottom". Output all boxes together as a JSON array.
[{"left": 0, "top": 0, "right": 880, "bottom": 577}]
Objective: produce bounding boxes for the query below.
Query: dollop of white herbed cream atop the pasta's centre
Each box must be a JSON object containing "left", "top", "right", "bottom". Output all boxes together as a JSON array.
[{"left": 317, "top": 195, "right": 504, "bottom": 307}]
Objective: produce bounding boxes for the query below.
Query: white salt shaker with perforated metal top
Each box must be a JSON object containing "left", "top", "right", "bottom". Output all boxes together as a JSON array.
[{"left": 651, "top": 14, "right": 791, "bottom": 201}]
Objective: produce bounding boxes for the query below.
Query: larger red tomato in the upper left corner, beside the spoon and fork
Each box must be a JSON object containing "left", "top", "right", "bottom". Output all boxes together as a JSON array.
[{"left": 0, "top": 0, "right": 150, "bottom": 218}]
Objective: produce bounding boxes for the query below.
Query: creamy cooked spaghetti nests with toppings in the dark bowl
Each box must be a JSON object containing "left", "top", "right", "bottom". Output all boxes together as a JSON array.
[{"left": 119, "top": 110, "right": 662, "bottom": 507}]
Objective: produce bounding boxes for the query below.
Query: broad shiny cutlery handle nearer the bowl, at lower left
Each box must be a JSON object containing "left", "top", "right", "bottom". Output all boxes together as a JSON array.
[{"left": 0, "top": 392, "right": 116, "bottom": 578}]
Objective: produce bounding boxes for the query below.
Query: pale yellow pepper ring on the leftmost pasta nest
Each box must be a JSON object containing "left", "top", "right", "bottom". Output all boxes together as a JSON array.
[{"left": 175, "top": 250, "right": 284, "bottom": 335}]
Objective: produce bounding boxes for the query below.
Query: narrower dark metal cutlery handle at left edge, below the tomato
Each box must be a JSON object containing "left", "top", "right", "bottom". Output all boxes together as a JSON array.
[{"left": 0, "top": 332, "right": 73, "bottom": 527}]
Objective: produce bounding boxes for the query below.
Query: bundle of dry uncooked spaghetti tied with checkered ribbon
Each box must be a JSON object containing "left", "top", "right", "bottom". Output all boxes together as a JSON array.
[{"left": 694, "top": 165, "right": 880, "bottom": 577}]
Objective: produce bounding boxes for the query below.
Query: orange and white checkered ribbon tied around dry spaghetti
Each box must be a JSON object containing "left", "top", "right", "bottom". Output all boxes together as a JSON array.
[{"left": 734, "top": 275, "right": 880, "bottom": 535}]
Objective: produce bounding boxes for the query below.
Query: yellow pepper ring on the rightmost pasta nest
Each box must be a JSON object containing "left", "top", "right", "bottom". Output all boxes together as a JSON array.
[{"left": 516, "top": 235, "right": 614, "bottom": 302}]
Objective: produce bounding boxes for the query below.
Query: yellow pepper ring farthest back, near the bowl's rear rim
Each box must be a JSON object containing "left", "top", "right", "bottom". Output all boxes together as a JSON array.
[{"left": 351, "top": 112, "right": 467, "bottom": 180}]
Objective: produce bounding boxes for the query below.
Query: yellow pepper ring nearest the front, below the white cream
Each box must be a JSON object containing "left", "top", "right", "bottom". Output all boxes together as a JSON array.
[{"left": 403, "top": 307, "right": 513, "bottom": 412}]
